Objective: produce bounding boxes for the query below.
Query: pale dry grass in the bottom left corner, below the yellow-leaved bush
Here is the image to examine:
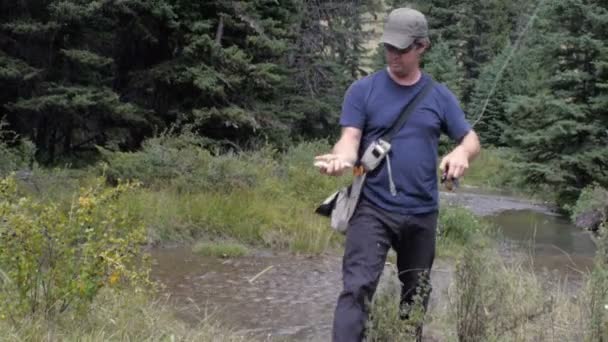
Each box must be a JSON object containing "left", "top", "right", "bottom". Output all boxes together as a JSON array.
[{"left": 0, "top": 291, "right": 251, "bottom": 342}]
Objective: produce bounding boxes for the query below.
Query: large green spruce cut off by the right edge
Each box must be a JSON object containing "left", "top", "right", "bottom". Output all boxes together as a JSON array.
[{"left": 508, "top": 0, "right": 608, "bottom": 204}]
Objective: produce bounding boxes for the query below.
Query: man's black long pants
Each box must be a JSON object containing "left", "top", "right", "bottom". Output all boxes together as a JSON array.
[{"left": 333, "top": 198, "right": 437, "bottom": 342}]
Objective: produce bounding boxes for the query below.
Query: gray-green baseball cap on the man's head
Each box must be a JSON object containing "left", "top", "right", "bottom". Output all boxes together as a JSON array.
[{"left": 380, "top": 8, "right": 429, "bottom": 49}]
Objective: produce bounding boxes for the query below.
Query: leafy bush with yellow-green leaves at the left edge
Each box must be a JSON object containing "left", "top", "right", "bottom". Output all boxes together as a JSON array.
[{"left": 0, "top": 177, "right": 151, "bottom": 321}]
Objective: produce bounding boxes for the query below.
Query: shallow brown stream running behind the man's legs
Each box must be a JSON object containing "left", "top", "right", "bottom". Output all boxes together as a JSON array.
[{"left": 152, "top": 189, "right": 595, "bottom": 341}]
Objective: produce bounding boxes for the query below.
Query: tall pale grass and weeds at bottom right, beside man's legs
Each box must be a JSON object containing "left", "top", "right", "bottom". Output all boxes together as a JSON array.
[{"left": 369, "top": 204, "right": 608, "bottom": 342}]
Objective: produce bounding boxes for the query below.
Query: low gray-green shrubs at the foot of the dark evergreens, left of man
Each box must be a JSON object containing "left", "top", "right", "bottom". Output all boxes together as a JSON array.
[{"left": 100, "top": 135, "right": 277, "bottom": 193}]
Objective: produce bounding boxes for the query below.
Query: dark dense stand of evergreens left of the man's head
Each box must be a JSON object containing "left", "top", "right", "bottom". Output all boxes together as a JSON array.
[{"left": 0, "top": 0, "right": 378, "bottom": 162}]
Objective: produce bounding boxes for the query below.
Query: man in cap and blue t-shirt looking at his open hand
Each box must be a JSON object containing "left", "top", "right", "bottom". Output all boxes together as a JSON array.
[{"left": 315, "top": 8, "right": 480, "bottom": 342}]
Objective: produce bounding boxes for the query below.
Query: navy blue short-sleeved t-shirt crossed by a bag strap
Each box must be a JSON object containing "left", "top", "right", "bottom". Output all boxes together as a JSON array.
[{"left": 340, "top": 69, "right": 471, "bottom": 214}]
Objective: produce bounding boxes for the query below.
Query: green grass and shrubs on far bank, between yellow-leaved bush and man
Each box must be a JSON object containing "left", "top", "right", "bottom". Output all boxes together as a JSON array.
[{"left": 106, "top": 140, "right": 348, "bottom": 253}]
